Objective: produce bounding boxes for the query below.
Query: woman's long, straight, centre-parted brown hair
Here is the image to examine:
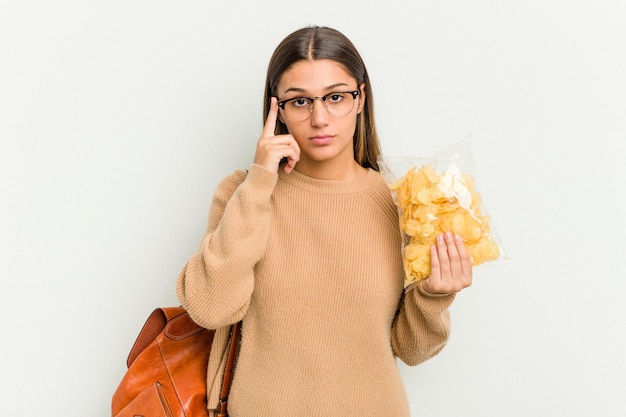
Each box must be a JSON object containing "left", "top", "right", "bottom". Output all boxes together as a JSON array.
[{"left": 263, "top": 26, "right": 381, "bottom": 171}]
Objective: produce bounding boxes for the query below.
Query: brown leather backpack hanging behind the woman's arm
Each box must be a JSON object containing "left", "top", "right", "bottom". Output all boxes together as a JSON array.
[{"left": 111, "top": 307, "right": 240, "bottom": 417}]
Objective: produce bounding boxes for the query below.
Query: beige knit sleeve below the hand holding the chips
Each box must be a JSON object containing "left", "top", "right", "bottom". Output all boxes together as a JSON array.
[{"left": 391, "top": 283, "right": 455, "bottom": 366}]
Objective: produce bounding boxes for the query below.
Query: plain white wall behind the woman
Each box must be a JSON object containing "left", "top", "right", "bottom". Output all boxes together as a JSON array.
[{"left": 0, "top": 0, "right": 626, "bottom": 417}]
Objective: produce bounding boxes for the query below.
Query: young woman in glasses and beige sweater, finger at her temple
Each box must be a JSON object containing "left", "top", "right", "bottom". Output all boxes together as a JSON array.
[{"left": 177, "top": 27, "right": 472, "bottom": 417}]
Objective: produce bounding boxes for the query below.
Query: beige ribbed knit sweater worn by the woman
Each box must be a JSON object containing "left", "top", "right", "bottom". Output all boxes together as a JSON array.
[{"left": 177, "top": 164, "right": 454, "bottom": 417}]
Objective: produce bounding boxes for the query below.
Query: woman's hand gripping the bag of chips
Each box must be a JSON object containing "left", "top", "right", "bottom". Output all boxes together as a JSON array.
[{"left": 422, "top": 232, "right": 472, "bottom": 294}]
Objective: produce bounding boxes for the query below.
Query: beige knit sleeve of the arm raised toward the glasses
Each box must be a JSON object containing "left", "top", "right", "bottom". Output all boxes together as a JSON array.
[{"left": 176, "top": 164, "right": 278, "bottom": 329}]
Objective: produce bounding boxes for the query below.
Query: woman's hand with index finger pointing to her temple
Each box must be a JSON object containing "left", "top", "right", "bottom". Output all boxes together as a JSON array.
[{"left": 254, "top": 97, "right": 300, "bottom": 174}]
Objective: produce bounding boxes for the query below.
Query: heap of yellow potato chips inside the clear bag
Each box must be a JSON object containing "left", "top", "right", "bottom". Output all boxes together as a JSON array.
[{"left": 390, "top": 165, "right": 500, "bottom": 287}]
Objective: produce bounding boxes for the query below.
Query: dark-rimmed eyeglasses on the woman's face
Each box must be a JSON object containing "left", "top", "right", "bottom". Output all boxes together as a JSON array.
[{"left": 278, "top": 90, "right": 361, "bottom": 122}]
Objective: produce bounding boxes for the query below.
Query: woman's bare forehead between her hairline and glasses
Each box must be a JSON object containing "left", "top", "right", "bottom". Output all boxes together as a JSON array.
[{"left": 278, "top": 59, "right": 357, "bottom": 95}]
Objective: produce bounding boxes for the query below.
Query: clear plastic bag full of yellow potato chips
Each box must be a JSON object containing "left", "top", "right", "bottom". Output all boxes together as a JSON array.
[{"left": 378, "top": 135, "right": 505, "bottom": 288}]
